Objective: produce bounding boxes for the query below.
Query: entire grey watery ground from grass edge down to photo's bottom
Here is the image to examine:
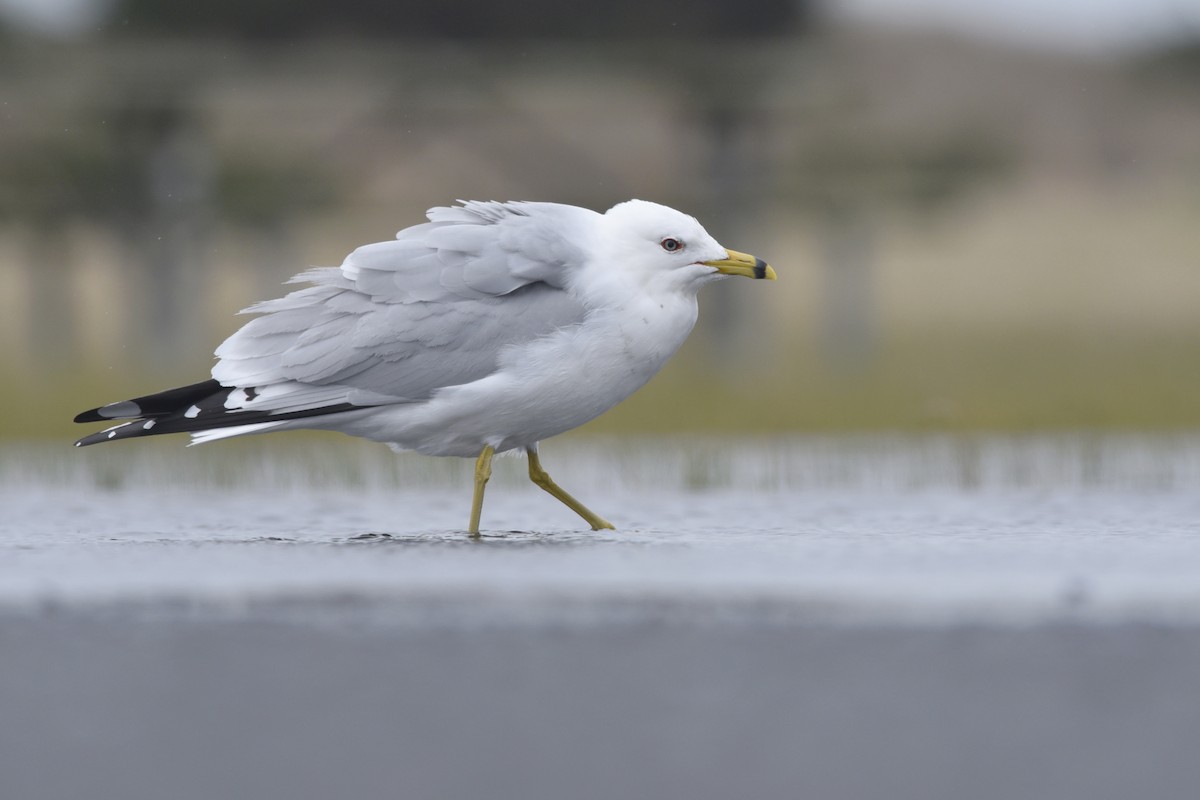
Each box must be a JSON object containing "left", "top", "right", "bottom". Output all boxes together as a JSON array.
[{"left": 7, "top": 435, "right": 1200, "bottom": 800}]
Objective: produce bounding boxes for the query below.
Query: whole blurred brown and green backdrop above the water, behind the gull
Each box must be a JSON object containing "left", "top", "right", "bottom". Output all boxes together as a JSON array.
[{"left": 0, "top": 0, "right": 1200, "bottom": 441}]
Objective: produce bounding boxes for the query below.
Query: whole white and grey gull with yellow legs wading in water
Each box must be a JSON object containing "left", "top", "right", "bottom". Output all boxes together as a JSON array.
[{"left": 74, "top": 200, "right": 775, "bottom": 535}]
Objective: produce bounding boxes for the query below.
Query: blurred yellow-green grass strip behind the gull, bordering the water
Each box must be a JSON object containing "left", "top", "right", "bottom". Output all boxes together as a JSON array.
[{"left": 11, "top": 333, "right": 1200, "bottom": 443}]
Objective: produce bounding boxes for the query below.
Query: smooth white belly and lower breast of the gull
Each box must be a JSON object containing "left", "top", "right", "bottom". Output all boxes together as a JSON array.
[{"left": 330, "top": 297, "right": 696, "bottom": 457}]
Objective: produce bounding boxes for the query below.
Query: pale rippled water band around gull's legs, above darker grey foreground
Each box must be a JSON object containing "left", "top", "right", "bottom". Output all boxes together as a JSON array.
[{"left": 0, "top": 435, "right": 1200, "bottom": 625}]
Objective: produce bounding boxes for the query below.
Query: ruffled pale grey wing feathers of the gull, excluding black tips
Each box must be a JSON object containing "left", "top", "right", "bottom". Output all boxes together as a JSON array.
[{"left": 212, "top": 203, "right": 595, "bottom": 411}]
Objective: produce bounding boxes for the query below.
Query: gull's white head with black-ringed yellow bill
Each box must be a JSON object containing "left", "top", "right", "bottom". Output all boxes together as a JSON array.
[{"left": 601, "top": 200, "right": 775, "bottom": 290}]
